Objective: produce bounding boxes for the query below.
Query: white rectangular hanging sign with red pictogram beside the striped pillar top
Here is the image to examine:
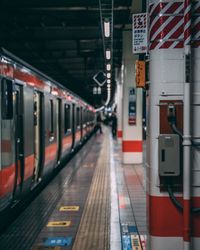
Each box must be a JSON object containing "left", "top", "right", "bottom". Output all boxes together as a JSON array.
[{"left": 133, "top": 13, "right": 148, "bottom": 54}]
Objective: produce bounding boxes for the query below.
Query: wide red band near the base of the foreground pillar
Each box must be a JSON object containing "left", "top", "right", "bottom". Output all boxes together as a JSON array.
[{"left": 147, "top": 196, "right": 200, "bottom": 237}]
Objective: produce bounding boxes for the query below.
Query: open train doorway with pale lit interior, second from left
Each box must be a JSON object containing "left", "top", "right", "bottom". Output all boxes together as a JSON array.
[{"left": 33, "top": 91, "right": 43, "bottom": 183}]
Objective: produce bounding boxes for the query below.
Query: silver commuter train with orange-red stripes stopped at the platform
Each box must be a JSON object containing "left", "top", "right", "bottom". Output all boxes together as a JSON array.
[{"left": 0, "top": 48, "right": 95, "bottom": 214}]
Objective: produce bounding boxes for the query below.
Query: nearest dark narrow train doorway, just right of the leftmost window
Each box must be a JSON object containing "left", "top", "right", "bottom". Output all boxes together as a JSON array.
[{"left": 13, "top": 85, "right": 24, "bottom": 199}]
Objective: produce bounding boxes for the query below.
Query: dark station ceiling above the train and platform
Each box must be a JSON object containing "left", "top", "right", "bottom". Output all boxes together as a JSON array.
[{"left": 0, "top": 0, "right": 132, "bottom": 105}]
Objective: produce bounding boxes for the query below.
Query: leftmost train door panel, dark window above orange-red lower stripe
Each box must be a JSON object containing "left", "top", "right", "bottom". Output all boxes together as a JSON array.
[{"left": 0, "top": 78, "right": 16, "bottom": 208}]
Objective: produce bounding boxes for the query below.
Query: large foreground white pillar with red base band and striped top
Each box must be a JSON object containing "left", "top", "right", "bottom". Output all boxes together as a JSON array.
[{"left": 147, "top": 0, "right": 200, "bottom": 250}]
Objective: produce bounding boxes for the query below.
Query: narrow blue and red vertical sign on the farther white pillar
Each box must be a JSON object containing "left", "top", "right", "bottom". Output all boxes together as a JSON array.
[{"left": 128, "top": 88, "right": 136, "bottom": 125}]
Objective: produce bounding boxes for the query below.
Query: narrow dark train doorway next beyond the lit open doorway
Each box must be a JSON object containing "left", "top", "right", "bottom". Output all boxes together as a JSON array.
[{"left": 56, "top": 99, "right": 62, "bottom": 164}]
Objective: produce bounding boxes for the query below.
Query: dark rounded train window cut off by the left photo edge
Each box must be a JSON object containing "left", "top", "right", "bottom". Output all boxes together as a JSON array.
[{"left": 1, "top": 79, "right": 13, "bottom": 120}]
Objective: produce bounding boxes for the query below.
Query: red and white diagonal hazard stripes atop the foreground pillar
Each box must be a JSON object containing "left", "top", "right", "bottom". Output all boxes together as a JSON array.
[{"left": 149, "top": 1, "right": 200, "bottom": 50}]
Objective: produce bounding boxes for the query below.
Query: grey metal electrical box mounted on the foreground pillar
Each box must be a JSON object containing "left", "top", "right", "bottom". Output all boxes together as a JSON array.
[{"left": 158, "top": 134, "right": 180, "bottom": 177}]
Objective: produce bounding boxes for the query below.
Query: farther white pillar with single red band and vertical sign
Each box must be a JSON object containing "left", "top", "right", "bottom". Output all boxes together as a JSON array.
[{"left": 121, "top": 27, "right": 143, "bottom": 164}]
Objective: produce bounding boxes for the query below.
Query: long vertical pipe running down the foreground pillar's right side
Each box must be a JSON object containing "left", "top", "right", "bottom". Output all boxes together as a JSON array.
[{"left": 183, "top": 0, "right": 191, "bottom": 250}]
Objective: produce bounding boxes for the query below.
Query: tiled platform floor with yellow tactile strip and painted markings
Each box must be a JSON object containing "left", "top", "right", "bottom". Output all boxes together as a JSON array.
[{"left": 0, "top": 127, "right": 147, "bottom": 250}]
